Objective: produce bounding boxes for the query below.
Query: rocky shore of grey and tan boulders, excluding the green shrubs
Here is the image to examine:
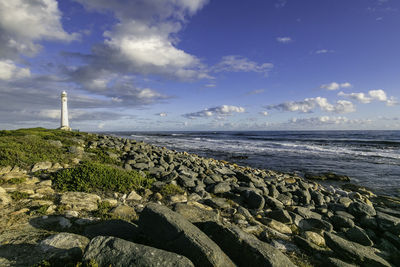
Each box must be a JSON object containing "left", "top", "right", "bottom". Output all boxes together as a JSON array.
[{"left": 0, "top": 129, "right": 400, "bottom": 266}]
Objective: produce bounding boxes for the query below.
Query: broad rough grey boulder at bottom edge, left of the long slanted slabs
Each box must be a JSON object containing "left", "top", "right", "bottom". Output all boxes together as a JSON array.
[{"left": 83, "top": 236, "right": 194, "bottom": 267}]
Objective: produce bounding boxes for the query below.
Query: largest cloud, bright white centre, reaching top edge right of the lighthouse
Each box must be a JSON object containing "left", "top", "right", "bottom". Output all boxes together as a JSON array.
[{"left": 70, "top": 0, "right": 209, "bottom": 79}]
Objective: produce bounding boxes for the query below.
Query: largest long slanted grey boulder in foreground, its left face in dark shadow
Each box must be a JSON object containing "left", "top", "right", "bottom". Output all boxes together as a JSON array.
[{"left": 139, "top": 203, "right": 235, "bottom": 266}]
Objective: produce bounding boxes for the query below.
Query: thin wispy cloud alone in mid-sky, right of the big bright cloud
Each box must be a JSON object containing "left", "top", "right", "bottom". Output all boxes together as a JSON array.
[{"left": 212, "top": 55, "right": 274, "bottom": 74}]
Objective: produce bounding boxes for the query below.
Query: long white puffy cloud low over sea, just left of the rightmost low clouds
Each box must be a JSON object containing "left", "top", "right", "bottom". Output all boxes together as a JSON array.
[{"left": 266, "top": 97, "right": 355, "bottom": 113}]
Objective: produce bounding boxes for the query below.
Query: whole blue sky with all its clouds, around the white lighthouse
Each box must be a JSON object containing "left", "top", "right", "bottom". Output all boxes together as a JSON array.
[{"left": 0, "top": 0, "right": 400, "bottom": 131}]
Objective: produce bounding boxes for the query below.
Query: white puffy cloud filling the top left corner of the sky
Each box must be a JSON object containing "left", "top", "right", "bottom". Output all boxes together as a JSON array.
[{"left": 0, "top": 0, "right": 78, "bottom": 59}]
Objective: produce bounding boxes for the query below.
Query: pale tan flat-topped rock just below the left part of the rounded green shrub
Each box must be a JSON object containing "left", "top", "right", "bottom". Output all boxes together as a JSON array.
[{"left": 60, "top": 192, "right": 101, "bottom": 211}]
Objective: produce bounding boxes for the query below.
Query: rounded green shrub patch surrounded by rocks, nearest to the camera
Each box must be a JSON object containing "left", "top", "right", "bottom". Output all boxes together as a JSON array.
[{"left": 51, "top": 162, "right": 154, "bottom": 193}]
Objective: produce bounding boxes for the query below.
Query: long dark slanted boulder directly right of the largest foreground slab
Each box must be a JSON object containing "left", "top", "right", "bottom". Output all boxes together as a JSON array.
[{"left": 200, "top": 222, "right": 295, "bottom": 267}]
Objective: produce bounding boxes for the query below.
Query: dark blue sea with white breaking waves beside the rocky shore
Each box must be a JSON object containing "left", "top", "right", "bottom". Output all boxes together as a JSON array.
[{"left": 113, "top": 131, "right": 400, "bottom": 196}]
